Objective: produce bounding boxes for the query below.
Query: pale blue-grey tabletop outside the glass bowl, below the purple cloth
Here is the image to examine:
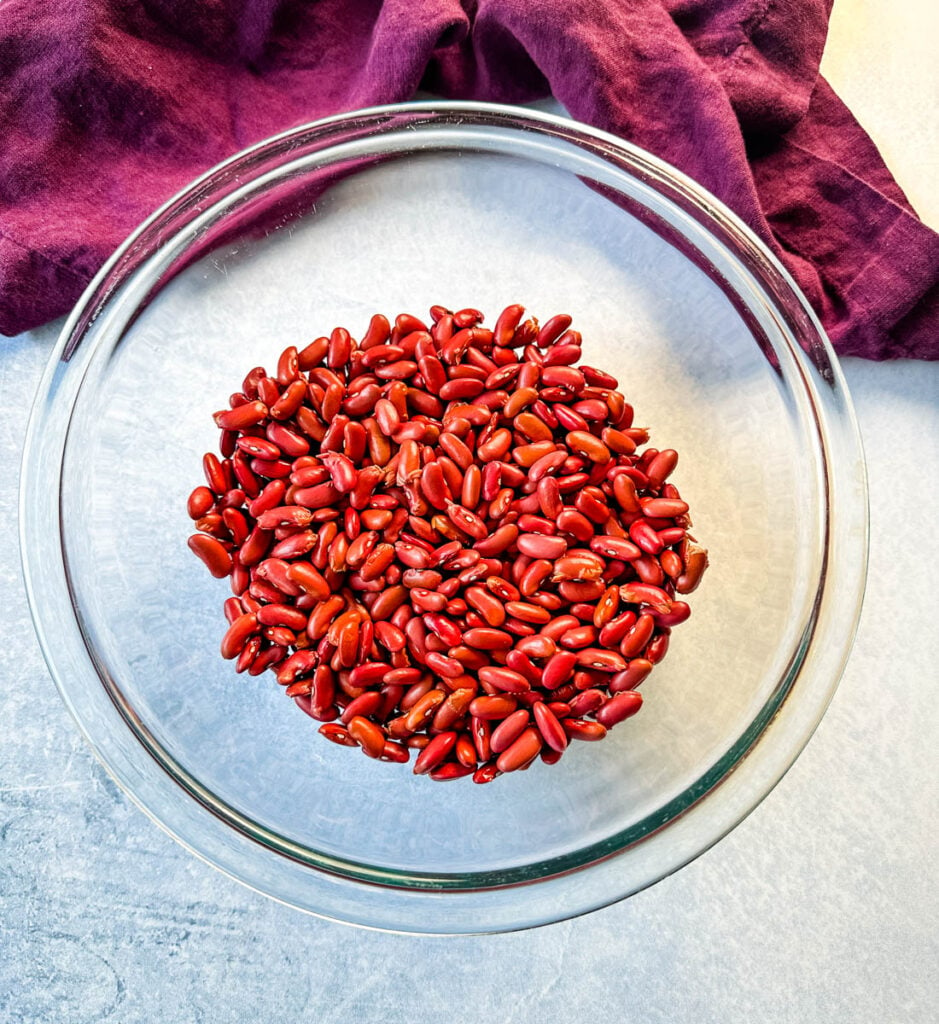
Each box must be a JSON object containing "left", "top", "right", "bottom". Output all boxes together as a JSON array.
[{"left": 0, "top": 315, "right": 939, "bottom": 1024}]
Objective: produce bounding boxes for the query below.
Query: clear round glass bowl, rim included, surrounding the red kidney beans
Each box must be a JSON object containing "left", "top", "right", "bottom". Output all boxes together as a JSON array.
[{"left": 22, "top": 103, "right": 866, "bottom": 933}]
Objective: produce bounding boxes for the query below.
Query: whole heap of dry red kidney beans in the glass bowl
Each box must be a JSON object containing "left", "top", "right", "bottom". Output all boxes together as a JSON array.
[{"left": 186, "top": 305, "right": 708, "bottom": 782}]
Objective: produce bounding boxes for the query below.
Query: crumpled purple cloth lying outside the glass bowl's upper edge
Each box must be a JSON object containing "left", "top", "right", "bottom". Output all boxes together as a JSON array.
[{"left": 0, "top": 0, "right": 939, "bottom": 358}]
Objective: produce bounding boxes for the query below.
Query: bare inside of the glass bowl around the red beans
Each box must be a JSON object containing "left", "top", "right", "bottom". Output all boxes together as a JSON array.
[{"left": 59, "top": 140, "right": 825, "bottom": 884}]
